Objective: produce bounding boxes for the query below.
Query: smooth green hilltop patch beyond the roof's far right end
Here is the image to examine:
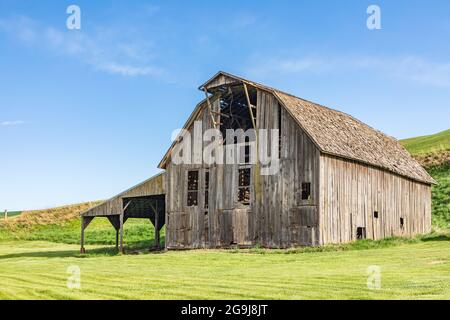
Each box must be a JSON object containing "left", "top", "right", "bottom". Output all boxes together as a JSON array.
[{"left": 401, "top": 130, "right": 450, "bottom": 155}]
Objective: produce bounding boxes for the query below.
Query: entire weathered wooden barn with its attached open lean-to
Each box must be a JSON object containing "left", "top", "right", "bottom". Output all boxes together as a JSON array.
[{"left": 82, "top": 72, "right": 435, "bottom": 251}]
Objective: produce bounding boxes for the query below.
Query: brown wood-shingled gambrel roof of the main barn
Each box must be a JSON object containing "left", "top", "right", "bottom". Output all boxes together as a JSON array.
[{"left": 160, "top": 71, "right": 436, "bottom": 184}]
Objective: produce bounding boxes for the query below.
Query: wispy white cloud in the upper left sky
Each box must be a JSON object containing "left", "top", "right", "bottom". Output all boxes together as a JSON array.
[{"left": 0, "top": 16, "right": 165, "bottom": 77}]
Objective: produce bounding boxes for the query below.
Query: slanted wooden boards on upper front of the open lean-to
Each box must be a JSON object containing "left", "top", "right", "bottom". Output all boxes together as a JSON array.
[{"left": 82, "top": 173, "right": 166, "bottom": 217}]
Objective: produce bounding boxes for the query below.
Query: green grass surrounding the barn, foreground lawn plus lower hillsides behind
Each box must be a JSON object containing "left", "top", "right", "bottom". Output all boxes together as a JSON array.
[{"left": 0, "top": 131, "right": 450, "bottom": 299}]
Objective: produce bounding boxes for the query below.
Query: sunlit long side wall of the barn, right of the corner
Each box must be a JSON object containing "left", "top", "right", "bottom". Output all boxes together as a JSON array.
[{"left": 320, "top": 155, "right": 431, "bottom": 244}]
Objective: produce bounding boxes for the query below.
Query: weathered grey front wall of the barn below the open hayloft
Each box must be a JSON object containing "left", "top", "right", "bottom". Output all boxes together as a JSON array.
[{"left": 166, "top": 91, "right": 320, "bottom": 249}]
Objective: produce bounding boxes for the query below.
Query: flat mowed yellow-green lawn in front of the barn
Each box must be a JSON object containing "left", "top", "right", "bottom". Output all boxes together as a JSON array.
[{"left": 0, "top": 237, "right": 450, "bottom": 299}]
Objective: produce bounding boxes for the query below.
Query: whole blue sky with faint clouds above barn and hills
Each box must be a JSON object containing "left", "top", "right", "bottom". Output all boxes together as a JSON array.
[{"left": 0, "top": 0, "right": 450, "bottom": 210}]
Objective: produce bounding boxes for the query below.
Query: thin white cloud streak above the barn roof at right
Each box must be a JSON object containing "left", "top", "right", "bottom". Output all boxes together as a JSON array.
[{"left": 247, "top": 56, "right": 450, "bottom": 88}]
